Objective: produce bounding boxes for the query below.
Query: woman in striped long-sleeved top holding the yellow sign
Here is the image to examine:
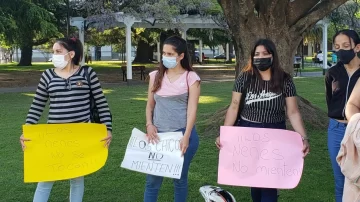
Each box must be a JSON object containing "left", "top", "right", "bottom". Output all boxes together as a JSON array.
[{"left": 20, "top": 38, "right": 112, "bottom": 202}]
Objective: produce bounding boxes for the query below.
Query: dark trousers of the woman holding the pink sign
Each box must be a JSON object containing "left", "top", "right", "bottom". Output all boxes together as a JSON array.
[{"left": 239, "top": 120, "right": 286, "bottom": 202}]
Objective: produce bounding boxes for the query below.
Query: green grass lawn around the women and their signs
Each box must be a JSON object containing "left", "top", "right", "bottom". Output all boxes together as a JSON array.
[{"left": 0, "top": 78, "right": 334, "bottom": 202}]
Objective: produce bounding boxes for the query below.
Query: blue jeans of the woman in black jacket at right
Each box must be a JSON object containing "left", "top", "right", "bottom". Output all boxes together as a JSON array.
[{"left": 328, "top": 119, "right": 346, "bottom": 202}]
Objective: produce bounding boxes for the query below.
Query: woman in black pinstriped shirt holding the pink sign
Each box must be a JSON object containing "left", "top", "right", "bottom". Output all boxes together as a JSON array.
[{"left": 216, "top": 39, "right": 310, "bottom": 202}]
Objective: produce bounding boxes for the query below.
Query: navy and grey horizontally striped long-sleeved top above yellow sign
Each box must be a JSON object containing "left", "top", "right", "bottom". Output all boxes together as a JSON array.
[{"left": 26, "top": 67, "right": 112, "bottom": 131}]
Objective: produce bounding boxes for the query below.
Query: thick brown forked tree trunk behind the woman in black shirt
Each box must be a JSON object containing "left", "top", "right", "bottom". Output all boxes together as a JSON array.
[{"left": 218, "top": 0, "right": 346, "bottom": 76}]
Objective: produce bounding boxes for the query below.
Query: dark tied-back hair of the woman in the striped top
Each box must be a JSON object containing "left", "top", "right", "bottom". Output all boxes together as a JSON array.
[{"left": 55, "top": 37, "right": 84, "bottom": 65}]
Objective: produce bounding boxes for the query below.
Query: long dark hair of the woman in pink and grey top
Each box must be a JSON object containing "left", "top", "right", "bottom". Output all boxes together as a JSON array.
[{"left": 152, "top": 36, "right": 194, "bottom": 92}]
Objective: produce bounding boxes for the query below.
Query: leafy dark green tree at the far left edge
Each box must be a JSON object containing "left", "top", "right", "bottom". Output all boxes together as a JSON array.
[{"left": 0, "top": 0, "right": 66, "bottom": 66}]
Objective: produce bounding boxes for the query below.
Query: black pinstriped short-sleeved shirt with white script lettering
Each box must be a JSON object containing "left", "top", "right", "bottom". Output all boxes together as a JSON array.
[{"left": 233, "top": 72, "right": 296, "bottom": 123}]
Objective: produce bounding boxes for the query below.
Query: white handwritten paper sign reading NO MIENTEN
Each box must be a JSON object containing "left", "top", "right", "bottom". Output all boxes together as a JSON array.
[{"left": 121, "top": 128, "right": 184, "bottom": 179}]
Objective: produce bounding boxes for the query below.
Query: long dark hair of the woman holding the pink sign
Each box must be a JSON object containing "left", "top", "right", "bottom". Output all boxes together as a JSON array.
[{"left": 243, "top": 39, "right": 290, "bottom": 93}]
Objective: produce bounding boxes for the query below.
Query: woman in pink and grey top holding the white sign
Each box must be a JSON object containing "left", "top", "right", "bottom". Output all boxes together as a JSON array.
[{"left": 144, "top": 36, "right": 200, "bottom": 202}]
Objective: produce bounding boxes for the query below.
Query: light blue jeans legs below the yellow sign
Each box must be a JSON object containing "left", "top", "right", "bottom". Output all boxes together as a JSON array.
[{"left": 33, "top": 177, "right": 84, "bottom": 202}]
